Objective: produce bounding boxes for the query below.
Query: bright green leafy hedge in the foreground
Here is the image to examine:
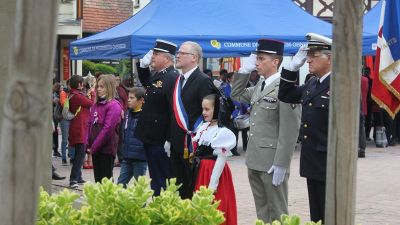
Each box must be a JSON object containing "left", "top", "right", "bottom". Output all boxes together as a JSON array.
[{"left": 36, "top": 176, "right": 321, "bottom": 225}]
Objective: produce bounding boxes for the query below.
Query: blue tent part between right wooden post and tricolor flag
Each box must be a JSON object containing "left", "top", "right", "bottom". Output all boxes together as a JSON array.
[{"left": 363, "top": 1, "right": 382, "bottom": 55}]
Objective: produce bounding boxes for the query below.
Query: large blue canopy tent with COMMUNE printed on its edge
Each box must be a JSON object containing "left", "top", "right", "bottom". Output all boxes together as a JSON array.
[{"left": 70, "top": 0, "right": 332, "bottom": 60}]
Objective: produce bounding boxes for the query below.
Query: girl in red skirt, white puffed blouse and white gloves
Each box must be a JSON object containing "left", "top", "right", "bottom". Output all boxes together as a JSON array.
[{"left": 193, "top": 94, "right": 237, "bottom": 225}]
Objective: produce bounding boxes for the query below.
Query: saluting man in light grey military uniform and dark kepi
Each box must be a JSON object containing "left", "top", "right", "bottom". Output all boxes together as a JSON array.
[{"left": 232, "top": 39, "right": 301, "bottom": 223}]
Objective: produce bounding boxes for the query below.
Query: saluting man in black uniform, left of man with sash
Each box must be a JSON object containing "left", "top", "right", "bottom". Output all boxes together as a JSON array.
[{"left": 135, "top": 39, "right": 179, "bottom": 196}]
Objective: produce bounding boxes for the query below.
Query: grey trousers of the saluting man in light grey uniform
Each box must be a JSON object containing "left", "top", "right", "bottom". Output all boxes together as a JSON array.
[{"left": 247, "top": 168, "right": 289, "bottom": 223}]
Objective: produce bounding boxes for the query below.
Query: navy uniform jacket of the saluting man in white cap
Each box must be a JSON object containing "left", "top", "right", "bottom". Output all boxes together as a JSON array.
[{"left": 278, "top": 69, "right": 330, "bottom": 181}]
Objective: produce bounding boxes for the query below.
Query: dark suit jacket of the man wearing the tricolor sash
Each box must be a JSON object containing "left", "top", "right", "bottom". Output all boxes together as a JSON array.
[{"left": 170, "top": 68, "right": 215, "bottom": 154}]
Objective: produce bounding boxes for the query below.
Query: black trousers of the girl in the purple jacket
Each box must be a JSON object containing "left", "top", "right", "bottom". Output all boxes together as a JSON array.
[{"left": 92, "top": 153, "right": 115, "bottom": 183}]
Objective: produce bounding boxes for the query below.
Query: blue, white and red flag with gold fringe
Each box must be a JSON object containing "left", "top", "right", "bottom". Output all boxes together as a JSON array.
[{"left": 372, "top": 0, "right": 400, "bottom": 118}]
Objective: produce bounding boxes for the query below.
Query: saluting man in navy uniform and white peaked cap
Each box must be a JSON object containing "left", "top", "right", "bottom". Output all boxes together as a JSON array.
[{"left": 278, "top": 33, "right": 332, "bottom": 223}]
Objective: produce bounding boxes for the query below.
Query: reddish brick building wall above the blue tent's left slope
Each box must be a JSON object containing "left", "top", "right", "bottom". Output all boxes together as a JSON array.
[{"left": 83, "top": 0, "right": 133, "bottom": 33}]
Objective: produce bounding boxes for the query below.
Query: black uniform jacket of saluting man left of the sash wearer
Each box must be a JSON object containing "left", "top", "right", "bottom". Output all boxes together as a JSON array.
[{"left": 135, "top": 63, "right": 179, "bottom": 146}]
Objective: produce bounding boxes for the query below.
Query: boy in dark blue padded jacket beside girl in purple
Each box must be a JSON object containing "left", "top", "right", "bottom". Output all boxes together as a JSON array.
[{"left": 118, "top": 87, "right": 147, "bottom": 187}]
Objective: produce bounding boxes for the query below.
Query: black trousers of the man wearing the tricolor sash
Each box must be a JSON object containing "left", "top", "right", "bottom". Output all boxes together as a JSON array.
[{"left": 171, "top": 147, "right": 193, "bottom": 199}]
